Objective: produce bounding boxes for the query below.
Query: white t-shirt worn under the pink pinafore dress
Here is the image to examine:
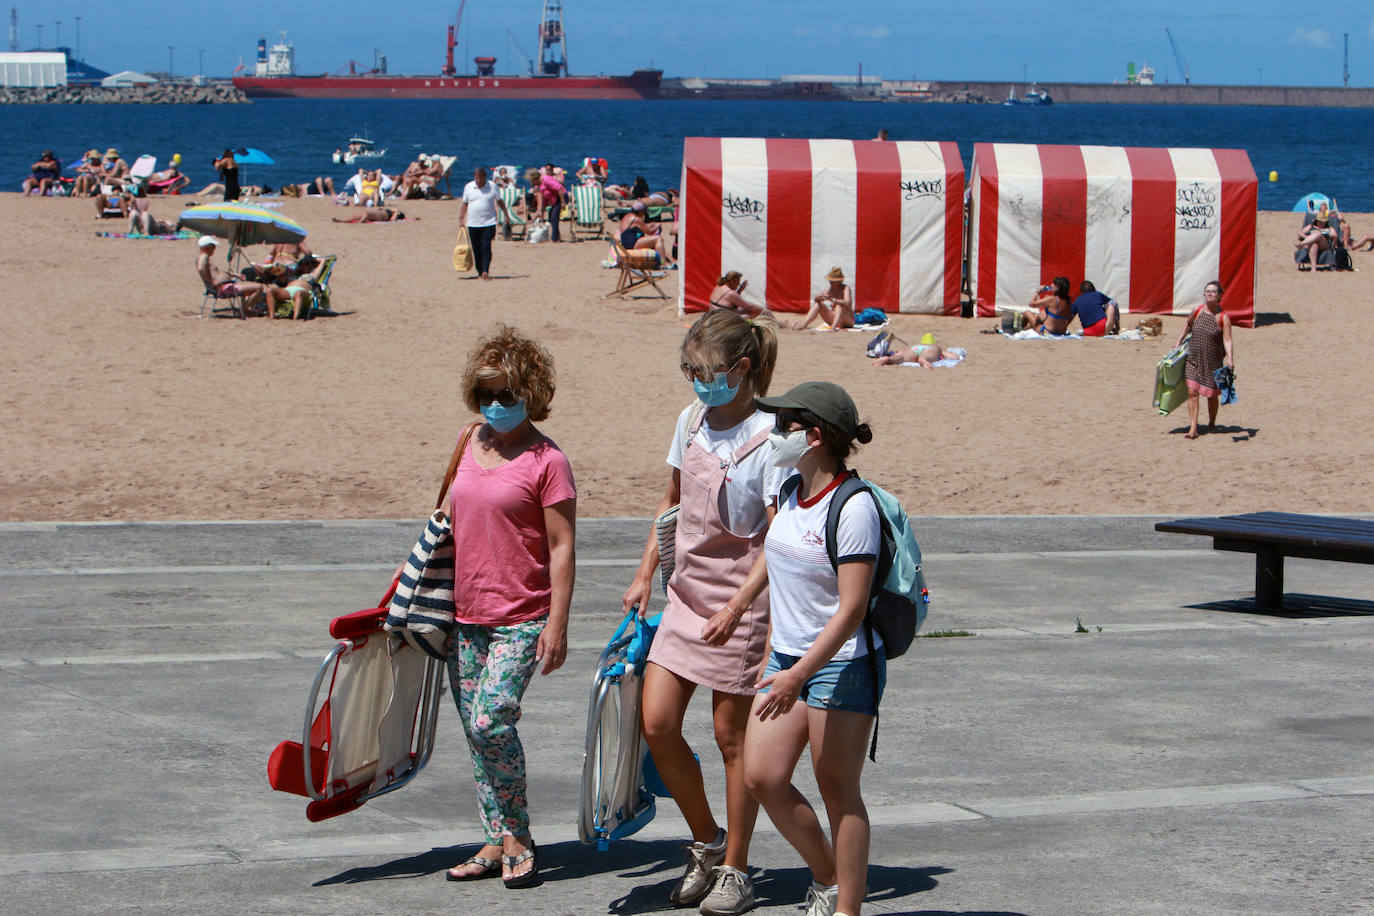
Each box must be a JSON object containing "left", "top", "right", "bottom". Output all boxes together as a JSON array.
[{"left": 668, "top": 405, "right": 791, "bottom": 537}]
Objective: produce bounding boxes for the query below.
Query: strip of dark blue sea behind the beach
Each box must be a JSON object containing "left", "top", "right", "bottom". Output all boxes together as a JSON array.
[{"left": 0, "top": 99, "right": 1374, "bottom": 211}]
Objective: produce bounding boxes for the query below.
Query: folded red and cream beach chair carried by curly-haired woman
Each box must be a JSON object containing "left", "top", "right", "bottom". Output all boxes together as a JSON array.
[{"left": 267, "top": 585, "right": 445, "bottom": 821}]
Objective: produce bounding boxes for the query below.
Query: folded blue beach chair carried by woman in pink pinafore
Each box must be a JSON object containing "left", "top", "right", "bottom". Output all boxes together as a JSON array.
[{"left": 577, "top": 606, "right": 668, "bottom": 851}]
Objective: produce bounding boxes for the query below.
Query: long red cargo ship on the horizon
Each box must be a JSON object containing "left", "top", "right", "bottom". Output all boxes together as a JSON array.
[{"left": 234, "top": 0, "right": 664, "bottom": 99}]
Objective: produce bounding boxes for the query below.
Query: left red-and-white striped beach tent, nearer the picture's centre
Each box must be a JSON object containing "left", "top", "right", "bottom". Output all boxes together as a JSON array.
[{"left": 677, "top": 137, "right": 963, "bottom": 314}]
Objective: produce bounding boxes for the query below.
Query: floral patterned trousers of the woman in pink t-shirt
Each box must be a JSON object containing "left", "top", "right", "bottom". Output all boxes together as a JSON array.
[{"left": 448, "top": 617, "right": 548, "bottom": 846}]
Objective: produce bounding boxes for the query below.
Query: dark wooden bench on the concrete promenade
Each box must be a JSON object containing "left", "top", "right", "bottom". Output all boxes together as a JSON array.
[{"left": 1154, "top": 512, "right": 1374, "bottom": 611}]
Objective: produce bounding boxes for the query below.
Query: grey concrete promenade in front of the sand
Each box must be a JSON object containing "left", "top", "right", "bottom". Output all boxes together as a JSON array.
[{"left": 0, "top": 516, "right": 1374, "bottom": 916}]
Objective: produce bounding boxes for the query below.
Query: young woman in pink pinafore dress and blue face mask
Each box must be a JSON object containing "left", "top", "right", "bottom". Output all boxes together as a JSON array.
[{"left": 624, "top": 310, "right": 786, "bottom": 916}]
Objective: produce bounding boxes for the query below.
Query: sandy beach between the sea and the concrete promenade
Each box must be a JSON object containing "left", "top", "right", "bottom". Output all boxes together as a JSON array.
[{"left": 0, "top": 194, "right": 1374, "bottom": 520}]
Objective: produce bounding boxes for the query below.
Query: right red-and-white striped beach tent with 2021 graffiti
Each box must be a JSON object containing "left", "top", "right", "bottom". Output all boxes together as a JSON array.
[{"left": 969, "top": 143, "right": 1259, "bottom": 327}]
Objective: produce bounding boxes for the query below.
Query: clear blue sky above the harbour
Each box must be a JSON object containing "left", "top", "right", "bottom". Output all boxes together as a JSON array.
[{"left": 18, "top": 0, "right": 1374, "bottom": 87}]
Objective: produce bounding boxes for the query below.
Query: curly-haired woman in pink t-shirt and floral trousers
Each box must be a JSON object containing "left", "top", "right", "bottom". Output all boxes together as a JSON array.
[{"left": 436, "top": 325, "right": 577, "bottom": 887}]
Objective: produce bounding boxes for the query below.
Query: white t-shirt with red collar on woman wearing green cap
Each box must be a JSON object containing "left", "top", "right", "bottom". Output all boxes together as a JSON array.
[{"left": 764, "top": 477, "right": 882, "bottom": 662}]
